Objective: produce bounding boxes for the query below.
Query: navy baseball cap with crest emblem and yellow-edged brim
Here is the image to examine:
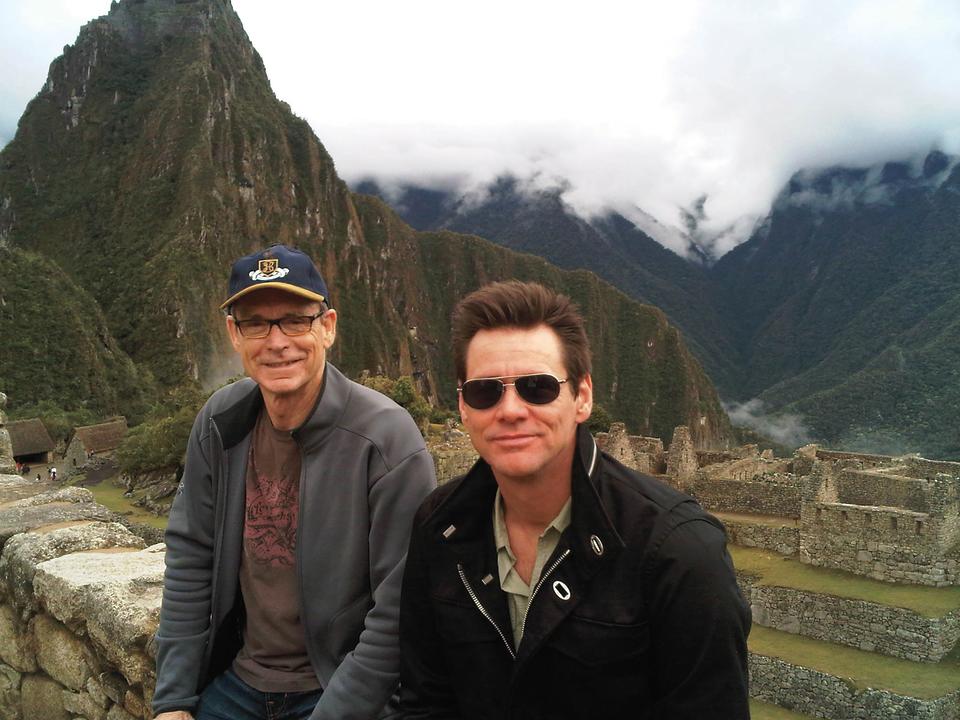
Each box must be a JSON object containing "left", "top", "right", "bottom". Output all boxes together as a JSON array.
[{"left": 220, "top": 245, "right": 329, "bottom": 310}]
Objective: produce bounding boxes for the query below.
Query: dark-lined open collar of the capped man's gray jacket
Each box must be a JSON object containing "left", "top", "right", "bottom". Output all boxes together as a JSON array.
[{"left": 213, "top": 362, "right": 351, "bottom": 450}]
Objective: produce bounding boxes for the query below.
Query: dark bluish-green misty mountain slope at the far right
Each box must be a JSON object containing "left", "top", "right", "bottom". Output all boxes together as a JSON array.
[{"left": 714, "top": 153, "right": 960, "bottom": 458}]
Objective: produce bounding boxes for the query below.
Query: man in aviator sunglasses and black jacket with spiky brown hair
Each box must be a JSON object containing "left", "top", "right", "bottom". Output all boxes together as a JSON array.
[{"left": 400, "top": 282, "right": 750, "bottom": 720}]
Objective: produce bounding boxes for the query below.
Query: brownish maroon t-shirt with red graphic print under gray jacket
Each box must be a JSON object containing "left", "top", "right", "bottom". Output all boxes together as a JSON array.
[{"left": 233, "top": 411, "right": 320, "bottom": 692}]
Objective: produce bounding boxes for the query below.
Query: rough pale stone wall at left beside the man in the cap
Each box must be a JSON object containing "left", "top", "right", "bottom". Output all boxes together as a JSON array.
[{"left": 0, "top": 475, "right": 164, "bottom": 720}]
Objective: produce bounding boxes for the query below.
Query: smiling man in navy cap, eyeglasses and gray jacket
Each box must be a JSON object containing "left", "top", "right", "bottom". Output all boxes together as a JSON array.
[{"left": 153, "top": 245, "right": 436, "bottom": 720}]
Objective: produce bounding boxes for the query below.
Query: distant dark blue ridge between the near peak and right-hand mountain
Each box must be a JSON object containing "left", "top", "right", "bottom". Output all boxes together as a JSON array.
[{"left": 356, "top": 176, "right": 740, "bottom": 393}]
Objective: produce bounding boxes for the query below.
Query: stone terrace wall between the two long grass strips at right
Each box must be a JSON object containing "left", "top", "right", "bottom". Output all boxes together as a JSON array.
[{"left": 741, "top": 584, "right": 960, "bottom": 663}]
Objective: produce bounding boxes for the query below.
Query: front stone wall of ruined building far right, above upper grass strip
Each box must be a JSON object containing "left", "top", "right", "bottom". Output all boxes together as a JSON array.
[{"left": 800, "top": 502, "right": 960, "bottom": 587}]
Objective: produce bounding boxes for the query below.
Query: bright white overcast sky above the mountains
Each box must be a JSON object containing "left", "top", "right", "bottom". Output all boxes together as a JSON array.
[{"left": 0, "top": 0, "right": 960, "bottom": 255}]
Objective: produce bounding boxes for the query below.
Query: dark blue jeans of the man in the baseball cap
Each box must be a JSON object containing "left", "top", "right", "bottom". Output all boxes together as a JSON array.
[{"left": 194, "top": 669, "right": 323, "bottom": 720}]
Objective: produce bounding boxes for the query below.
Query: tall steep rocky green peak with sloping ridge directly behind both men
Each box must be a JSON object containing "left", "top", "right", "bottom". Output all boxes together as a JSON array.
[{"left": 0, "top": 0, "right": 730, "bottom": 444}]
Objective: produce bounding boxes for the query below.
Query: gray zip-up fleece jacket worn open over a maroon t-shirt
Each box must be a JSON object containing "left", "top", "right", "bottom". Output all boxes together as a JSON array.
[{"left": 153, "top": 363, "right": 436, "bottom": 720}]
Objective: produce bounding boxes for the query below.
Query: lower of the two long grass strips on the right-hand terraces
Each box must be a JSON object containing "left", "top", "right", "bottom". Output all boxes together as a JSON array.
[{"left": 748, "top": 625, "right": 960, "bottom": 700}]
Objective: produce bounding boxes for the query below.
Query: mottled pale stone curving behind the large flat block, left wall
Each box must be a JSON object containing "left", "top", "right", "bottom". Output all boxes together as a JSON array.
[{"left": 0, "top": 524, "right": 144, "bottom": 610}]
